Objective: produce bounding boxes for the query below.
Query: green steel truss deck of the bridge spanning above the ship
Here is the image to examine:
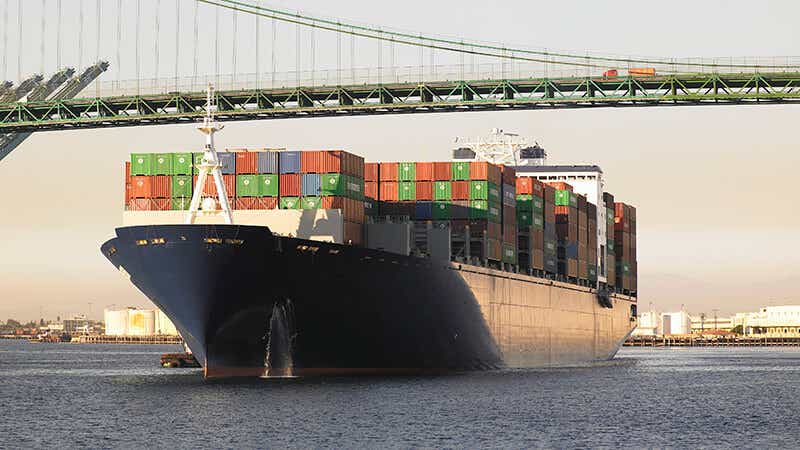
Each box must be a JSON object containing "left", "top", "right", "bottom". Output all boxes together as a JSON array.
[{"left": 0, "top": 73, "right": 800, "bottom": 132}]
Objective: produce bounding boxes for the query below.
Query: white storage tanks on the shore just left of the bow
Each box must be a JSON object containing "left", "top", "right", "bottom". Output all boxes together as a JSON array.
[{"left": 103, "top": 307, "right": 178, "bottom": 336}]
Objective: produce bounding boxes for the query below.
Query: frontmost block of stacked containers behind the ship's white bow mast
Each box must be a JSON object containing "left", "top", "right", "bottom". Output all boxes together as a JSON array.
[{"left": 126, "top": 150, "right": 364, "bottom": 244}]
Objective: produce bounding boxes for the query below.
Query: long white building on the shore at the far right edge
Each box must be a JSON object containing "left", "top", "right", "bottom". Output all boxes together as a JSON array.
[{"left": 731, "top": 305, "right": 800, "bottom": 337}]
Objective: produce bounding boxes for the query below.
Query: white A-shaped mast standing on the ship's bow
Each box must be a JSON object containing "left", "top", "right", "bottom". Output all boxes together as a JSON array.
[{"left": 185, "top": 84, "right": 233, "bottom": 225}]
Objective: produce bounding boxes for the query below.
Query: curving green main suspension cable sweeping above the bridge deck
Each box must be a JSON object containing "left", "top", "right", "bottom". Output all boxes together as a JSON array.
[{"left": 198, "top": 0, "right": 800, "bottom": 70}]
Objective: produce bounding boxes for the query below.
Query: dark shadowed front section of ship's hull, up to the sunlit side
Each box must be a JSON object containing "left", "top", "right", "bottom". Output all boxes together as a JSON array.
[{"left": 102, "top": 225, "right": 506, "bottom": 377}]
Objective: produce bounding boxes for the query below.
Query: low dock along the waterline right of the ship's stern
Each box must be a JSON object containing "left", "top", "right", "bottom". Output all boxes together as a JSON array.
[{"left": 623, "top": 335, "right": 800, "bottom": 347}]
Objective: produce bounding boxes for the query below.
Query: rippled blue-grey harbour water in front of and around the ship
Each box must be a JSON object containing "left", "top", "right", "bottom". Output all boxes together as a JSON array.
[{"left": 0, "top": 341, "right": 800, "bottom": 448}]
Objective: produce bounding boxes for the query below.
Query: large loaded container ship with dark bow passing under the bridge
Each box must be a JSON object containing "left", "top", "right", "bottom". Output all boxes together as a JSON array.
[{"left": 101, "top": 97, "right": 636, "bottom": 377}]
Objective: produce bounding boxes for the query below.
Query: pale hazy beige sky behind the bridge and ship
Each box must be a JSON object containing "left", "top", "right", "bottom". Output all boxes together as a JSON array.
[{"left": 0, "top": 0, "right": 800, "bottom": 320}]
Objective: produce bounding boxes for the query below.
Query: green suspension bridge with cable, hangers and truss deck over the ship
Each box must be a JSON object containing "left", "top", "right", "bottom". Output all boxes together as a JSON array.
[{"left": 0, "top": 0, "right": 800, "bottom": 159}]
